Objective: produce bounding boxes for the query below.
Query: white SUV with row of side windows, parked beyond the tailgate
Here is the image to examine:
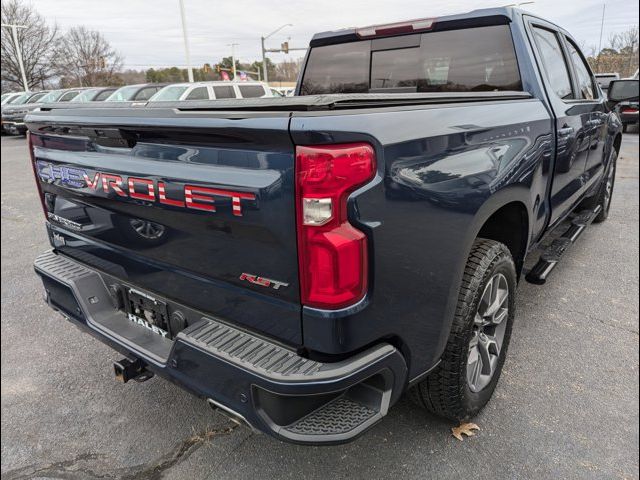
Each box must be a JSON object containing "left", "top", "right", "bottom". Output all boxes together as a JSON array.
[{"left": 149, "top": 81, "right": 272, "bottom": 102}]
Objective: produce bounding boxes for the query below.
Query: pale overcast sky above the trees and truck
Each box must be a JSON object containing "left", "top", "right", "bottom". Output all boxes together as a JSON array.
[{"left": 27, "top": 0, "right": 638, "bottom": 70}]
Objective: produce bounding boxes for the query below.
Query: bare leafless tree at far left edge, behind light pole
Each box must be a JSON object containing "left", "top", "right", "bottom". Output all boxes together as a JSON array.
[{"left": 0, "top": 0, "right": 57, "bottom": 89}]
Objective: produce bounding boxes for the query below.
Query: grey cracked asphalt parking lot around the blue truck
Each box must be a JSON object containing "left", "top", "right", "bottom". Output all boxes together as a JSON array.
[{"left": 1, "top": 131, "right": 639, "bottom": 480}]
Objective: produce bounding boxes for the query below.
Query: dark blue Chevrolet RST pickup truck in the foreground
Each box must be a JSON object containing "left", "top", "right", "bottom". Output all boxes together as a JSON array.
[{"left": 26, "top": 8, "right": 636, "bottom": 444}]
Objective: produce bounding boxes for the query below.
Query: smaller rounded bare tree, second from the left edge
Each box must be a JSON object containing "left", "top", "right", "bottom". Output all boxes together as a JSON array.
[{"left": 53, "top": 26, "right": 122, "bottom": 87}]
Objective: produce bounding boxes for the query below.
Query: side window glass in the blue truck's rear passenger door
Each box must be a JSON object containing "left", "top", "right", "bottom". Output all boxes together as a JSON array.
[{"left": 533, "top": 27, "right": 573, "bottom": 100}]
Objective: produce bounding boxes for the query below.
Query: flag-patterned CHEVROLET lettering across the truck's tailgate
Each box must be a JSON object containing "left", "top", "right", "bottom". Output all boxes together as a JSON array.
[{"left": 36, "top": 160, "right": 256, "bottom": 217}]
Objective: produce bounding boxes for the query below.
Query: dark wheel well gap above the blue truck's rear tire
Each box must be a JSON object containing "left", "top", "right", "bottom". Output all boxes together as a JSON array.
[{"left": 478, "top": 202, "right": 529, "bottom": 276}]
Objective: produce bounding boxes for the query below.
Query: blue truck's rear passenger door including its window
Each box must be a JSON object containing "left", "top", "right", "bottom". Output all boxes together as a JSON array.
[{"left": 529, "top": 19, "right": 593, "bottom": 225}]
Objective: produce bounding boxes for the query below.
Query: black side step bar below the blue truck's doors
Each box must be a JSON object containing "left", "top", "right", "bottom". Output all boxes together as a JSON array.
[{"left": 525, "top": 205, "right": 602, "bottom": 285}]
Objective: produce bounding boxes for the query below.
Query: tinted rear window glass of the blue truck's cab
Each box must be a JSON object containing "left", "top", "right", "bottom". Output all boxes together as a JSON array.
[{"left": 301, "top": 25, "right": 522, "bottom": 95}]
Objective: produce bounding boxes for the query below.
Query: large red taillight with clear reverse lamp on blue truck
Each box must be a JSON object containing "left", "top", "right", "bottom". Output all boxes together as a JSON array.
[{"left": 296, "top": 143, "right": 376, "bottom": 309}]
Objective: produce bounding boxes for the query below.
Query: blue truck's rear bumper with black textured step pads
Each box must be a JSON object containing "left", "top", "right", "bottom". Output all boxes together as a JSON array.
[{"left": 34, "top": 251, "right": 407, "bottom": 444}]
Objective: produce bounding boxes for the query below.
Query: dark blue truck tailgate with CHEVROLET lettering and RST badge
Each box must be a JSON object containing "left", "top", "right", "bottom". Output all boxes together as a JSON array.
[{"left": 28, "top": 108, "right": 301, "bottom": 345}]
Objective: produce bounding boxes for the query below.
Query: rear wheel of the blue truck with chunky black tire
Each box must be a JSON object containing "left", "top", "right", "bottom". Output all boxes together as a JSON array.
[{"left": 409, "top": 238, "right": 517, "bottom": 421}]
